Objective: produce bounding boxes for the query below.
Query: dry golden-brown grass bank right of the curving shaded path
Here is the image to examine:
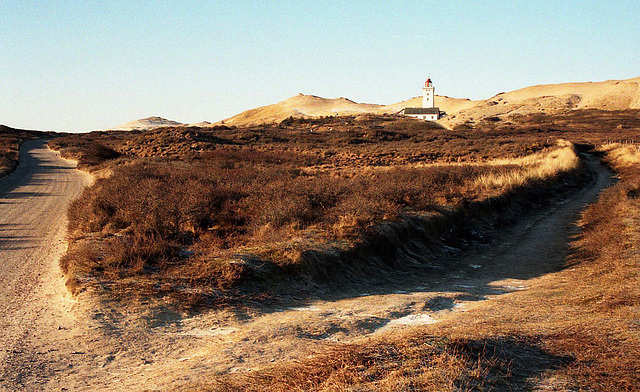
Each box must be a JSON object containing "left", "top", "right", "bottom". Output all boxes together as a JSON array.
[{"left": 189, "top": 143, "right": 640, "bottom": 391}]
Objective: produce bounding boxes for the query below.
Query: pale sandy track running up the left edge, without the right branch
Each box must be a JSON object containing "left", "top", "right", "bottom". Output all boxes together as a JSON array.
[{"left": 0, "top": 140, "right": 91, "bottom": 390}]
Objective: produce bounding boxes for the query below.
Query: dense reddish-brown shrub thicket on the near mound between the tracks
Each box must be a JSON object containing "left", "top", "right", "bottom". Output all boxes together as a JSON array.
[{"left": 69, "top": 144, "right": 576, "bottom": 284}]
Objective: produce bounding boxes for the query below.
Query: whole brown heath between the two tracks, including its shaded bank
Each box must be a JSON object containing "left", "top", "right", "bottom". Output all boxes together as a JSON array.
[{"left": 51, "top": 117, "right": 581, "bottom": 305}]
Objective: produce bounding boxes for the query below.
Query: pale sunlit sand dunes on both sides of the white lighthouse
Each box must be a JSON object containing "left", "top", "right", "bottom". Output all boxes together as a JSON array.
[{"left": 216, "top": 77, "right": 640, "bottom": 126}]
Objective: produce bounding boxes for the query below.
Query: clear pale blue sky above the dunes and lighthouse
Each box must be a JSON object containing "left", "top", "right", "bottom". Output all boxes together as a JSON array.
[{"left": 0, "top": 0, "right": 640, "bottom": 131}]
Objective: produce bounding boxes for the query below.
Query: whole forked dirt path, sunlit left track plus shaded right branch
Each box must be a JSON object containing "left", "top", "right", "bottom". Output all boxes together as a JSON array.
[{"left": 0, "top": 142, "right": 611, "bottom": 391}]
